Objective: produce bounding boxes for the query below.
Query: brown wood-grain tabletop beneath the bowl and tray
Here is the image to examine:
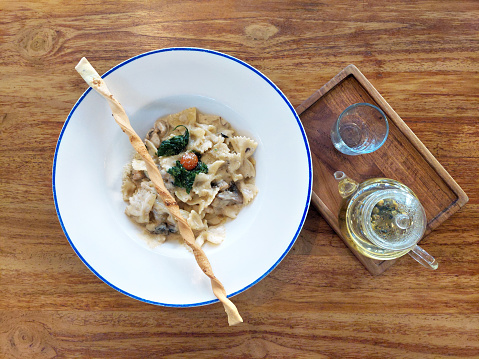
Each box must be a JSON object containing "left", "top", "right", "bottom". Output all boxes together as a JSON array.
[{"left": 0, "top": 0, "right": 479, "bottom": 358}]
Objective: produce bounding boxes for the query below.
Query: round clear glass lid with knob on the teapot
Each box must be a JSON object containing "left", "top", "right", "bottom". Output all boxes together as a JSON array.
[{"left": 361, "top": 189, "right": 427, "bottom": 250}]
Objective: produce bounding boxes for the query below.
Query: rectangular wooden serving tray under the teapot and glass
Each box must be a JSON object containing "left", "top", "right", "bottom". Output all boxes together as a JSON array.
[{"left": 296, "top": 65, "right": 468, "bottom": 275}]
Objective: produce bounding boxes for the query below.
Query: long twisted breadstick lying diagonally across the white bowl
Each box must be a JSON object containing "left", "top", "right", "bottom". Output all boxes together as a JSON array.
[{"left": 75, "top": 58, "right": 243, "bottom": 325}]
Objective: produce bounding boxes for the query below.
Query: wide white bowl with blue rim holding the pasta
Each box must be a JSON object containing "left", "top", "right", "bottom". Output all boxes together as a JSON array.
[{"left": 52, "top": 48, "right": 312, "bottom": 307}]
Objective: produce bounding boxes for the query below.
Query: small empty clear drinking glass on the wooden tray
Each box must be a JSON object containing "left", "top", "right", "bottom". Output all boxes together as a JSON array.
[{"left": 331, "top": 103, "right": 389, "bottom": 155}]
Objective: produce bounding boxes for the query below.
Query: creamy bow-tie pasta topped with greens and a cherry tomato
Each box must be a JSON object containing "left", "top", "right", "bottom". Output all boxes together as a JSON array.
[{"left": 121, "top": 108, "right": 258, "bottom": 245}]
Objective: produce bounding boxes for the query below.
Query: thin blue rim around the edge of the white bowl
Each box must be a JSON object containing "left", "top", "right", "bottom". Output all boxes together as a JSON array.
[{"left": 52, "top": 47, "right": 313, "bottom": 308}]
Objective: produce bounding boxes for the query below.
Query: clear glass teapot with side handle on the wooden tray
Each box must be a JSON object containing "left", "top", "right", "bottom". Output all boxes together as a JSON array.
[{"left": 334, "top": 171, "right": 438, "bottom": 269}]
